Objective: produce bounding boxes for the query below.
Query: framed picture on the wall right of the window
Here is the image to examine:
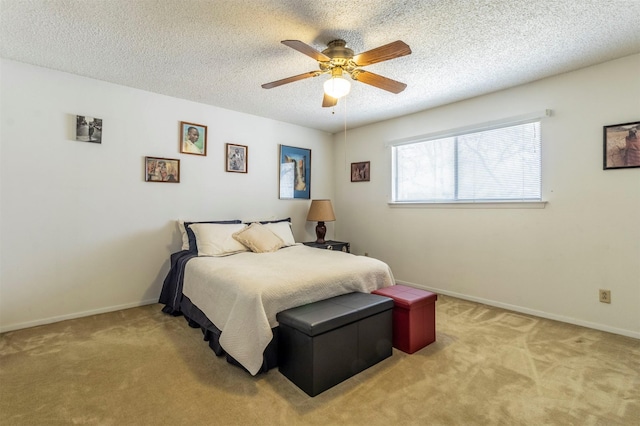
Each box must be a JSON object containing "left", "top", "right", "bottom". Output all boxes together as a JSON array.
[{"left": 603, "top": 121, "right": 640, "bottom": 170}]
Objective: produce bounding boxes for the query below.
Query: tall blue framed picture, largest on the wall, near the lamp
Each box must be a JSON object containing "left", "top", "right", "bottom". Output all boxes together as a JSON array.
[{"left": 278, "top": 145, "right": 311, "bottom": 200}]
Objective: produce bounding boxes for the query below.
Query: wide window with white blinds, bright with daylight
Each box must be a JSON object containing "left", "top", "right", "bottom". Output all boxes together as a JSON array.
[{"left": 392, "top": 120, "right": 542, "bottom": 203}]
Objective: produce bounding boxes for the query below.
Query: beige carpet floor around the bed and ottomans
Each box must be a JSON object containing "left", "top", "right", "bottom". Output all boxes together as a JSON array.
[{"left": 0, "top": 296, "right": 640, "bottom": 426}]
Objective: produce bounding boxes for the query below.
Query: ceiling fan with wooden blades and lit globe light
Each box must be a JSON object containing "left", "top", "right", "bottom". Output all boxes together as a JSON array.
[{"left": 262, "top": 39, "right": 411, "bottom": 107}]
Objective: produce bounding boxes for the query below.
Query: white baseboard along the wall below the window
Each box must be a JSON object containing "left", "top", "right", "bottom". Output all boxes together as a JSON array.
[{"left": 396, "top": 280, "right": 640, "bottom": 339}]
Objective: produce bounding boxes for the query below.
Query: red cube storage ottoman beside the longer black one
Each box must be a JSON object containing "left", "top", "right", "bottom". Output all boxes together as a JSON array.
[{"left": 373, "top": 285, "right": 438, "bottom": 354}]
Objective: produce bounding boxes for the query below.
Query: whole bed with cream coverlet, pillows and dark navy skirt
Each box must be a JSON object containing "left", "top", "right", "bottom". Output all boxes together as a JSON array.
[{"left": 160, "top": 220, "right": 394, "bottom": 375}]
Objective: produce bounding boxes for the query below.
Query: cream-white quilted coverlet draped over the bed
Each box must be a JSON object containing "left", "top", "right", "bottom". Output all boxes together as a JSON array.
[{"left": 182, "top": 245, "right": 394, "bottom": 375}]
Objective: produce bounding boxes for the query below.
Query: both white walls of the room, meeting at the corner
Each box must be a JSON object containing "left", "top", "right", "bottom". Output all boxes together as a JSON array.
[{"left": 0, "top": 55, "right": 640, "bottom": 337}]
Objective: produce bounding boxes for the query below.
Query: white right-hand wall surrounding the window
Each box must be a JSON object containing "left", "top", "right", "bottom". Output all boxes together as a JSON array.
[{"left": 334, "top": 55, "right": 640, "bottom": 338}]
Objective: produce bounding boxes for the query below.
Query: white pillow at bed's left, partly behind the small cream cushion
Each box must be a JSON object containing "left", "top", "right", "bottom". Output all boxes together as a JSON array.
[{"left": 189, "top": 223, "right": 248, "bottom": 256}]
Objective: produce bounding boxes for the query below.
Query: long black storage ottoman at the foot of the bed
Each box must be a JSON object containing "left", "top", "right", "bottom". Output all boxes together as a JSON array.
[{"left": 276, "top": 293, "right": 394, "bottom": 396}]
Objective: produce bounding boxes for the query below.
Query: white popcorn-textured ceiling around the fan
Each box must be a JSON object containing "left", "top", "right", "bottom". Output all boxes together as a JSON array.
[{"left": 0, "top": 0, "right": 640, "bottom": 133}]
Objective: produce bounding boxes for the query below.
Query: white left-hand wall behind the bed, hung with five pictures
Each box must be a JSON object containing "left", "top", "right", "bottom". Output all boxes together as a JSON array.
[{"left": 0, "top": 60, "right": 333, "bottom": 331}]
